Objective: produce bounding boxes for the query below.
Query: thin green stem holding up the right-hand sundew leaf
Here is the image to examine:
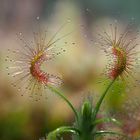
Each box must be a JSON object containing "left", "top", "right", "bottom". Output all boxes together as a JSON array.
[{"left": 93, "top": 79, "right": 116, "bottom": 121}]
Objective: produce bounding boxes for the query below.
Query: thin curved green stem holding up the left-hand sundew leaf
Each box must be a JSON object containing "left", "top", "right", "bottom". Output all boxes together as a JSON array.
[{"left": 47, "top": 85, "right": 78, "bottom": 120}]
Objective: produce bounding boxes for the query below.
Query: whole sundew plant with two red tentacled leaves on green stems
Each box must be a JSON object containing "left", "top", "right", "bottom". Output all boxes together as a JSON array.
[{"left": 7, "top": 19, "right": 140, "bottom": 140}]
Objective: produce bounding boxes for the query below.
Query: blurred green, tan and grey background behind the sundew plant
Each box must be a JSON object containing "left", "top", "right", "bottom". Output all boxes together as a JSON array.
[{"left": 0, "top": 0, "right": 140, "bottom": 140}]
